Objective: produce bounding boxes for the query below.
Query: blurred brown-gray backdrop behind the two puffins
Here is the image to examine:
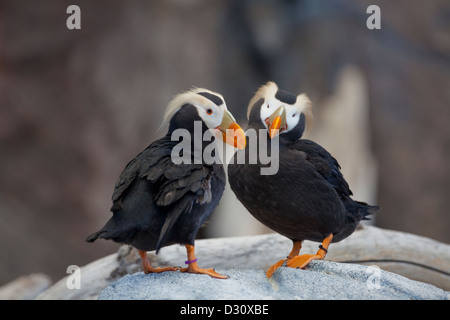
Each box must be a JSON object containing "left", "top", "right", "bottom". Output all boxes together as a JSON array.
[{"left": 0, "top": 0, "right": 450, "bottom": 285}]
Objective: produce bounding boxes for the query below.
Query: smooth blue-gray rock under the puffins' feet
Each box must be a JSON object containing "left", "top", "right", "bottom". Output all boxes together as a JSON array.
[{"left": 98, "top": 261, "right": 449, "bottom": 300}]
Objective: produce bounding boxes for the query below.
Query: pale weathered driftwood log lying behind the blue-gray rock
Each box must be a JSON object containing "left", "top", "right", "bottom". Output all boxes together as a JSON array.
[{"left": 37, "top": 226, "right": 450, "bottom": 300}]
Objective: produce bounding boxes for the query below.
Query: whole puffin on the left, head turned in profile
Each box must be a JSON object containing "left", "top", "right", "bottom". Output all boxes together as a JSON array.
[{"left": 86, "top": 88, "right": 246, "bottom": 279}]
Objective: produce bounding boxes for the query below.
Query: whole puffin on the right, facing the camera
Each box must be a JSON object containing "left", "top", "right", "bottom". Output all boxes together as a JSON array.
[{"left": 228, "top": 81, "right": 379, "bottom": 278}]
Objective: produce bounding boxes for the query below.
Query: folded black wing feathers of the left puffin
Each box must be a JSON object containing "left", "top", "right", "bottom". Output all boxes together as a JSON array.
[{"left": 111, "top": 137, "right": 212, "bottom": 250}]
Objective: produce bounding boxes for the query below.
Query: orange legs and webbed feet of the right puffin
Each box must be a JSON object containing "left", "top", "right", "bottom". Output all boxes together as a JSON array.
[{"left": 266, "top": 234, "right": 333, "bottom": 278}]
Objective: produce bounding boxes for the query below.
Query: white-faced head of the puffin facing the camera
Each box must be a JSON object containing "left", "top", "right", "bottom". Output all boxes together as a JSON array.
[{"left": 247, "top": 82, "right": 314, "bottom": 141}]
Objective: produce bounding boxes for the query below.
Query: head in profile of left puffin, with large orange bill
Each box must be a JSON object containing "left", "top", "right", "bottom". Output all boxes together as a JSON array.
[{"left": 161, "top": 88, "right": 246, "bottom": 149}]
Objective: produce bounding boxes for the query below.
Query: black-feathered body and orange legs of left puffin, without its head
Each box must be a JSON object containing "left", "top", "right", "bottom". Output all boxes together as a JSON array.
[{"left": 87, "top": 89, "right": 243, "bottom": 278}]
